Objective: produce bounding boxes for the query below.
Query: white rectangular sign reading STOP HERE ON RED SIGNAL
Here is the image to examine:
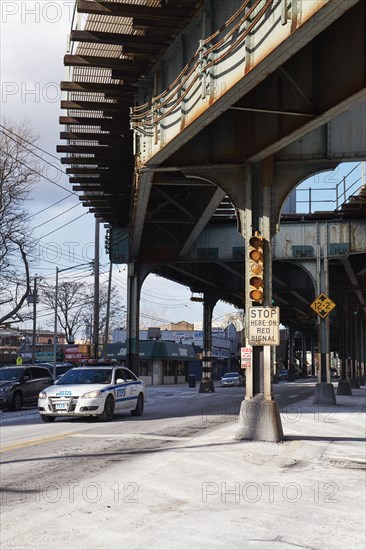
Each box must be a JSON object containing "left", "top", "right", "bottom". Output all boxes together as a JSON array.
[{"left": 248, "top": 306, "right": 280, "bottom": 346}]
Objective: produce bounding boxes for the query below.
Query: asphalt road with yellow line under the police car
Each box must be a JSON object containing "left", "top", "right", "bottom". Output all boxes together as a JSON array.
[{"left": 0, "top": 381, "right": 314, "bottom": 504}]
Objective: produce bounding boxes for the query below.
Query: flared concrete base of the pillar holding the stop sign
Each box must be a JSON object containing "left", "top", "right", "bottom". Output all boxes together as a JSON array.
[{"left": 235, "top": 393, "right": 283, "bottom": 443}]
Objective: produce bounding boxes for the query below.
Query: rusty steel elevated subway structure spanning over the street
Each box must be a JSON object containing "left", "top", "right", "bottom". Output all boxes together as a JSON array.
[{"left": 59, "top": 0, "right": 366, "bottom": 438}]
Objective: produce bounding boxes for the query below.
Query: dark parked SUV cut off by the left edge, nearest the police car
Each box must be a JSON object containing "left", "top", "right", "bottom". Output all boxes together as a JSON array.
[{"left": 0, "top": 365, "right": 54, "bottom": 411}]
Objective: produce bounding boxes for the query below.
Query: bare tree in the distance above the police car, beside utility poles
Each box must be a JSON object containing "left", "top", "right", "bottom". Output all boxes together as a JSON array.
[{"left": 42, "top": 281, "right": 90, "bottom": 342}]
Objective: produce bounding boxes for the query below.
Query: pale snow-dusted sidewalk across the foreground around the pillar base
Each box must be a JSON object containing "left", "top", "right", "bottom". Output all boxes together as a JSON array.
[{"left": 1, "top": 388, "right": 366, "bottom": 550}]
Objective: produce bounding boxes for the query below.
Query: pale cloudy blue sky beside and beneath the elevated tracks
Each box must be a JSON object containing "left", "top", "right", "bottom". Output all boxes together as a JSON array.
[{"left": 0, "top": 0, "right": 364, "bottom": 328}]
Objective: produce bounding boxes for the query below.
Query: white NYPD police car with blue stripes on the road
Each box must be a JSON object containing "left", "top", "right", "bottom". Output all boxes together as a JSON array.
[{"left": 38, "top": 366, "right": 145, "bottom": 422}]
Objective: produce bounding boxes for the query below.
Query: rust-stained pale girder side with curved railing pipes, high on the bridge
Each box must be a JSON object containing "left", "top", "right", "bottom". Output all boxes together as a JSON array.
[{"left": 130, "top": 0, "right": 304, "bottom": 163}]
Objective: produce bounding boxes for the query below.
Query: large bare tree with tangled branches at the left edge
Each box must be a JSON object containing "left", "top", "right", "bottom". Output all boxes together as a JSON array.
[{"left": 0, "top": 120, "right": 38, "bottom": 324}]
